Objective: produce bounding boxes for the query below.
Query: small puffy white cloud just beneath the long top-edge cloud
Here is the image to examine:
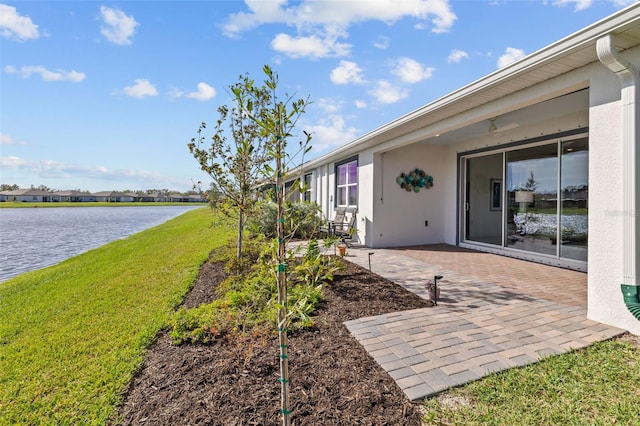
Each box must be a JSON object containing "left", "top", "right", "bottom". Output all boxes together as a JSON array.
[{"left": 271, "top": 33, "right": 351, "bottom": 59}]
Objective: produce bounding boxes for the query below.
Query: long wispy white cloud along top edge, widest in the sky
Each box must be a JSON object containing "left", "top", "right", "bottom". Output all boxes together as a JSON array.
[{"left": 223, "top": 0, "right": 457, "bottom": 36}]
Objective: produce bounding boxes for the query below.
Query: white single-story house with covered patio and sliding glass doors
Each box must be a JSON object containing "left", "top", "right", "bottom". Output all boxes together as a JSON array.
[{"left": 298, "top": 3, "right": 640, "bottom": 334}]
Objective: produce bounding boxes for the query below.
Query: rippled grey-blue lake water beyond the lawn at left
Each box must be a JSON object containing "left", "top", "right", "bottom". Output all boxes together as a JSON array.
[{"left": 0, "top": 205, "right": 202, "bottom": 282}]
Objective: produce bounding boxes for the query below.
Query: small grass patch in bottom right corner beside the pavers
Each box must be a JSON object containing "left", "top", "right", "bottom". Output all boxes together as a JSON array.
[{"left": 425, "top": 339, "right": 640, "bottom": 426}]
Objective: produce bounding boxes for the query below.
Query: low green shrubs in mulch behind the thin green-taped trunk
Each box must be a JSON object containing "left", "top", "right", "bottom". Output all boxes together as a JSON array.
[{"left": 169, "top": 236, "right": 341, "bottom": 344}]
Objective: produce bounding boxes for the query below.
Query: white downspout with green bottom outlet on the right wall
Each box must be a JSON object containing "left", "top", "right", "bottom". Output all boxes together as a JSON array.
[{"left": 596, "top": 35, "right": 640, "bottom": 320}]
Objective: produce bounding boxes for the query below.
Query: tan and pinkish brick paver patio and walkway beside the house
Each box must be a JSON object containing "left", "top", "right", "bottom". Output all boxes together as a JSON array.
[{"left": 345, "top": 245, "right": 625, "bottom": 400}]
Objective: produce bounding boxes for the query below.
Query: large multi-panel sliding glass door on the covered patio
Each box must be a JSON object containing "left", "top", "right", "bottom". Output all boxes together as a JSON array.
[{"left": 461, "top": 137, "right": 589, "bottom": 262}]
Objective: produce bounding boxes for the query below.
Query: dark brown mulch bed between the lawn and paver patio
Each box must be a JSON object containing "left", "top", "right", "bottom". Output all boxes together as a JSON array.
[{"left": 119, "top": 255, "right": 429, "bottom": 426}]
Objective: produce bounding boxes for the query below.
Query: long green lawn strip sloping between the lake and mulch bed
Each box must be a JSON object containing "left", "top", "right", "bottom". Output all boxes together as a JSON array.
[{"left": 0, "top": 208, "right": 233, "bottom": 425}]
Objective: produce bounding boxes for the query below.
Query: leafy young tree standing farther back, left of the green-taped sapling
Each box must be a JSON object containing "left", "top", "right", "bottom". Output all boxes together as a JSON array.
[{"left": 188, "top": 75, "right": 270, "bottom": 258}]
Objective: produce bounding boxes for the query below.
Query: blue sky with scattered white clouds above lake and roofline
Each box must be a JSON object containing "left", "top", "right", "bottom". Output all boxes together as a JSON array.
[{"left": 0, "top": 0, "right": 634, "bottom": 192}]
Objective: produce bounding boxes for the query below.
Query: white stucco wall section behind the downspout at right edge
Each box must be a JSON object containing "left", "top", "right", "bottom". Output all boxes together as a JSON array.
[{"left": 588, "top": 45, "right": 640, "bottom": 335}]
